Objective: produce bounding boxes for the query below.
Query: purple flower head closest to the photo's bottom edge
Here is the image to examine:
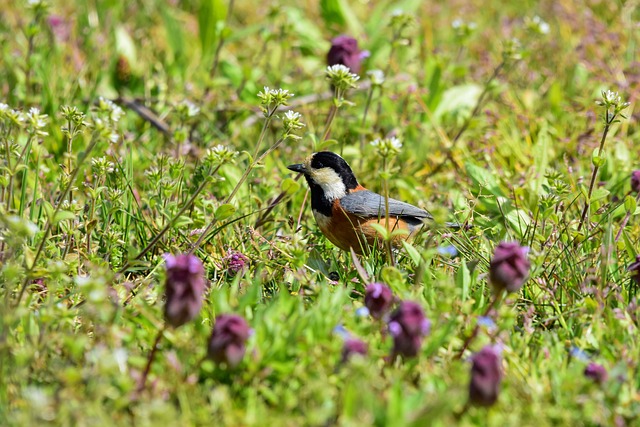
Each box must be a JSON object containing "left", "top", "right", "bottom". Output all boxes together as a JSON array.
[{"left": 469, "top": 345, "right": 502, "bottom": 406}]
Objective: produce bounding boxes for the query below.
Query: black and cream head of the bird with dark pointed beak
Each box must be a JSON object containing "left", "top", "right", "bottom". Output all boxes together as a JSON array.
[{"left": 287, "top": 151, "right": 358, "bottom": 201}]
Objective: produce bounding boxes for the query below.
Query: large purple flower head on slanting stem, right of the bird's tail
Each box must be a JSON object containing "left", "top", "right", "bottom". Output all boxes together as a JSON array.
[{"left": 489, "top": 242, "right": 531, "bottom": 292}]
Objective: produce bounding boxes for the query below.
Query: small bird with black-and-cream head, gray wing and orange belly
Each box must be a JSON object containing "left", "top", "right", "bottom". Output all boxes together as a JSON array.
[{"left": 287, "top": 151, "right": 456, "bottom": 255}]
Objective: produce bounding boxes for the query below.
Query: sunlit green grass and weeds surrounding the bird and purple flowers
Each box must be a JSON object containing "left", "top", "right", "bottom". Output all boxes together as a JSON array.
[{"left": 0, "top": 0, "right": 640, "bottom": 426}]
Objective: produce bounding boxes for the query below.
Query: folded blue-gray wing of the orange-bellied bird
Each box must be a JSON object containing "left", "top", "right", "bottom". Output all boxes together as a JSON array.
[{"left": 340, "top": 190, "right": 433, "bottom": 224}]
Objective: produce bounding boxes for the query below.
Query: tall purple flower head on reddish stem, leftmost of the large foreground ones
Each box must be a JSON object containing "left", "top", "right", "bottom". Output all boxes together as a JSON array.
[{"left": 164, "top": 254, "right": 206, "bottom": 328}]
